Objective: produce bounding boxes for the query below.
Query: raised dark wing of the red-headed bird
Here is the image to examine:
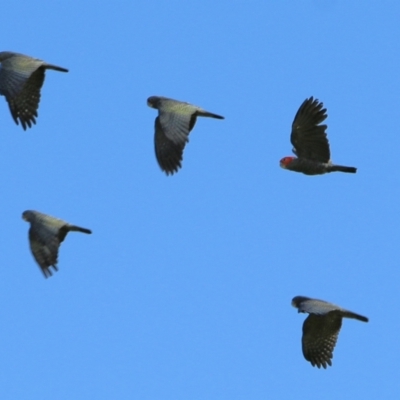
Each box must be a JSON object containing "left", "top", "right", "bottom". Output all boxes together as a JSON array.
[{"left": 290, "top": 97, "right": 330, "bottom": 163}]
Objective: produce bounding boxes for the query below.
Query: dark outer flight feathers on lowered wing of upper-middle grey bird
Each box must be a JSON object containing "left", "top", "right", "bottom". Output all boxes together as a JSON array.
[{"left": 154, "top": 117, "right": 188, "bottom": 174}]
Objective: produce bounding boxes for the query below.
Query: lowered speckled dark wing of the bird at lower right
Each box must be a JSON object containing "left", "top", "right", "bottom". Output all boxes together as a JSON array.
[{"left": 302, "top": 311, "right": 342, "bottom": 368}]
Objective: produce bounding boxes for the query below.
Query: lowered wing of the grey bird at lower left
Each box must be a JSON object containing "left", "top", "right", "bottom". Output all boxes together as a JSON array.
[{"left": 29, "top": 223, "right": 60, "bottom": 278}]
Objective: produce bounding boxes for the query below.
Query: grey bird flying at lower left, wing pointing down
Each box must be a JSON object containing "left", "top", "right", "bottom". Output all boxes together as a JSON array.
[{"left": 22, "top": 210, "right": 92, "bottom": 278}]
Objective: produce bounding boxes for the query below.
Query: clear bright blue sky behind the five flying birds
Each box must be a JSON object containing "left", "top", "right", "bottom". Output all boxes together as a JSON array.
[{"left": 0, "top": 0, "right": 400, "bottom": 400}]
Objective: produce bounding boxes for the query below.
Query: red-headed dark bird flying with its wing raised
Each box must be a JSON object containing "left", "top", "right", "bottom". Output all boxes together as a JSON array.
[{"left": 280, "top": 97, "right": 357, "bottom": 175}]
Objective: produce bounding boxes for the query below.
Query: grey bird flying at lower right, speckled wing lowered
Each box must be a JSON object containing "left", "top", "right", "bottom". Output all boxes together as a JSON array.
[{"left": 292, "top": 296, "right": 368, "bottom": 368}]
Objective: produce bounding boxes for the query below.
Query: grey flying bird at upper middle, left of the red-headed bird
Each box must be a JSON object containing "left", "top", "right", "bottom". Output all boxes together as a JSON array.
[{"left": 147, "top": 96, "right": 224, "bottom": 175}]
